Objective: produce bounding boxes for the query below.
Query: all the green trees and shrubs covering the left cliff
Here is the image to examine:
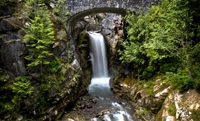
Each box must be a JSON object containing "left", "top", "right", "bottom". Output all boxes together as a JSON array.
[{"left": 0, "top": 0, "right": 71, "bottom": 120}]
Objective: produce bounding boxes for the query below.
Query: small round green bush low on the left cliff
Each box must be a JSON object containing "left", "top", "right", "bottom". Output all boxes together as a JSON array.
[{"left": 10, "top": 76, "right": 34, "bottom": 103}]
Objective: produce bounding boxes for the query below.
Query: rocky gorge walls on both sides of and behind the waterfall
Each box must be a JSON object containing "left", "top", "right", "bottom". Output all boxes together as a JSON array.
[{"left": 0, "top": 0, "right": 200, "bottom": 121}]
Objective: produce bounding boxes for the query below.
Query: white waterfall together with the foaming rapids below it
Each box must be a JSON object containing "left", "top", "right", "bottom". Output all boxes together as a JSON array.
[{"left": 88, "top": 32, "right": 133, "bottom": 121}]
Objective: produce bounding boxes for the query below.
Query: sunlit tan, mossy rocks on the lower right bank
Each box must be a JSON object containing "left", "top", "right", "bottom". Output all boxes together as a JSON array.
[{"left": 113, "top": 74, "right": 200, "bottom": 121}]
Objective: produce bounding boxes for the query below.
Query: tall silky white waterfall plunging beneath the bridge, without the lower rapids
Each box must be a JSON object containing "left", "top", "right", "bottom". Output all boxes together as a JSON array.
[{"left": 88, "top": 32, "right": 112, "bottom": 97}]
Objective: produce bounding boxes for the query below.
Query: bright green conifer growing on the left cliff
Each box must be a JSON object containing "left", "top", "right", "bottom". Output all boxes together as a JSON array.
[{"left": 24, "top": 3, "right": 55, "bottom": 73}]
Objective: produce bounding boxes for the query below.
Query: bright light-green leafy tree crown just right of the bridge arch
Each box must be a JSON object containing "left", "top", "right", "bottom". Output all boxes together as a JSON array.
[{"left": 120, "top": 0, "right": 190, "bottom": 63}]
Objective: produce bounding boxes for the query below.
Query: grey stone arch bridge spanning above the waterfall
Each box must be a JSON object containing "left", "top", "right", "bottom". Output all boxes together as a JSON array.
[{"left": 66, "top": 0, "right": 158, "bottom": 29}]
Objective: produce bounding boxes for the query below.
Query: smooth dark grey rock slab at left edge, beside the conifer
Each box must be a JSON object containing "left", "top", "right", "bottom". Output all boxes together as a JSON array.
[{"left": 0, "top": 38, "right": 27, "bottom": 76}]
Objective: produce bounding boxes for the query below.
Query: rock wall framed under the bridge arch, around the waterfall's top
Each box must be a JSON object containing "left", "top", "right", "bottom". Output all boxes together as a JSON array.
[{"left": 72, "top": 13, "right": 124, "bottom": 76}]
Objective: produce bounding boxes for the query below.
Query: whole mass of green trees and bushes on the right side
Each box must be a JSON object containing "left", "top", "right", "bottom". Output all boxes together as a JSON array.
[{"left": 118, "top": 0, "right": 200, "bottom": 90}]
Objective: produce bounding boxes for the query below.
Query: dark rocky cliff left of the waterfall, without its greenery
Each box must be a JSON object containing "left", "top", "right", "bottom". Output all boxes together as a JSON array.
[{"left": 0, "top": 2, "right": 91, "bottom": 121}]
